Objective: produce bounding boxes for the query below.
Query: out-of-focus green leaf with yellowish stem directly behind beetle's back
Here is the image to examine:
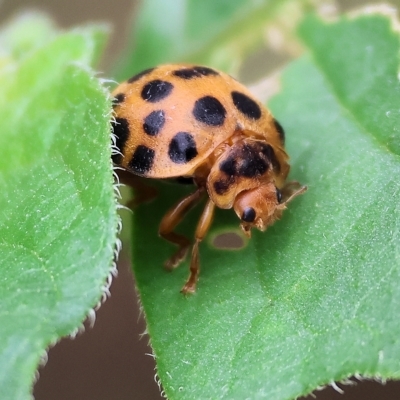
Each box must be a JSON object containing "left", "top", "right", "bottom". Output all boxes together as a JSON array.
[{"left": 112, "top": 0, "right": 313, "bottom": 79}]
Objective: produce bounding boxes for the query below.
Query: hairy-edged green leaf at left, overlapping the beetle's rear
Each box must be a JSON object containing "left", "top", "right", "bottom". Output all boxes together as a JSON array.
[{"left": 0, "top": 16, "right": 118, "bottom": 399}]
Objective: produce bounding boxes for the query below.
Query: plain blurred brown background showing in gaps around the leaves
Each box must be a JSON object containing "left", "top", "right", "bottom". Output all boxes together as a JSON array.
[{"left": 0, "top": 0, "right": 400, "bottom": 400}]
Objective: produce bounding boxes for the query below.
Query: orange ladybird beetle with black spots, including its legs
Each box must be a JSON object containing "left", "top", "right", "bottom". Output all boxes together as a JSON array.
[{"left": 112, "top": 64, "right": 306, "bottom": 293}]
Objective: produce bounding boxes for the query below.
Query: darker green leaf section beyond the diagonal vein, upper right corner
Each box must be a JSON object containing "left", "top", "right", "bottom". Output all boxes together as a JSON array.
[{"left": 301, "top": 11, "right": 400, "bottom": 155}]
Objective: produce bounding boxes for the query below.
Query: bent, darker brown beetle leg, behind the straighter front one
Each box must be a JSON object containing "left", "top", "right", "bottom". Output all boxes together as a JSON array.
[{"left": 158, "top": 187, "right": 204, "bottom": 269}]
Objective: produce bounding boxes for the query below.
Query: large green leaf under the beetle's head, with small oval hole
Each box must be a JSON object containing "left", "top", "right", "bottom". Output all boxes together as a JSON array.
[{"left": 134, "top": 10, "right": 400, "bottom": 400}]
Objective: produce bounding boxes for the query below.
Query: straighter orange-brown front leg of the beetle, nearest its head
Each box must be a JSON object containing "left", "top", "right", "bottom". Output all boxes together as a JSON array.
[{"left": 181, "top": 199, "right": 215, "bottom": 294}]
